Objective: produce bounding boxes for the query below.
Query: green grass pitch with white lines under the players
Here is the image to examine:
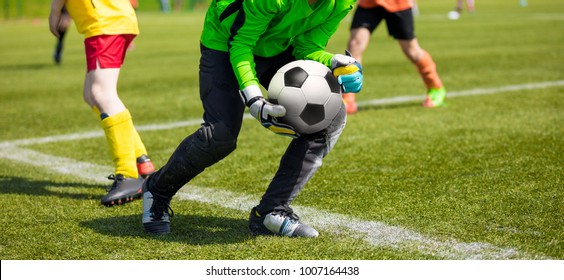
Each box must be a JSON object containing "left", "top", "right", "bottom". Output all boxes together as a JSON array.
[{"left": 0, "top": 0, "right": 564, "bottom": 260}]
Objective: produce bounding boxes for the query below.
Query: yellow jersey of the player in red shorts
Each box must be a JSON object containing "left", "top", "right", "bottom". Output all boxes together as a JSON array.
[{"left": 65, "top": 0, "right": 139, "bottom": 38}]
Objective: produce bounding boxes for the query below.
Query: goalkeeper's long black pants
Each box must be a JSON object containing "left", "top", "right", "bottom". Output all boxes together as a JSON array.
[{"left": 147, "top": 46, "right": 346, "bottom": 213}]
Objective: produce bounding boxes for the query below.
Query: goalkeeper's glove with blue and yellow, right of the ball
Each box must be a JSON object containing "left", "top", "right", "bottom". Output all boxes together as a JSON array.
[{"left": 331, "top": 51, "right": 363, "bottom": 93}]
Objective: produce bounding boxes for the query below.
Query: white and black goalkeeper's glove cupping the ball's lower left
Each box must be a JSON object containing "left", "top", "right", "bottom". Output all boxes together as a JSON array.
[{"left": 239, "top": 85, "right": 300, "bottom": 138}]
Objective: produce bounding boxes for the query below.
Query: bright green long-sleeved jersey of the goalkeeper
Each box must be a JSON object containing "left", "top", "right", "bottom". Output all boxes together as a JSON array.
[{"left": 200, "top": 0, "right": 356, "bottom": 89}]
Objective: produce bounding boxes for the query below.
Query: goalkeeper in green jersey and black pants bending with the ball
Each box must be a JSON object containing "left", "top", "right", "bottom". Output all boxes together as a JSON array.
[{"left": 143, "top": 0, "right": 362, "bottom": 237}]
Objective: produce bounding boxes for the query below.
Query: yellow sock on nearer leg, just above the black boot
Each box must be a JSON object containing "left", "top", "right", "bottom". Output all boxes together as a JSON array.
[{"left": 102, "top": 109, "right": 139, "bottom": 178}]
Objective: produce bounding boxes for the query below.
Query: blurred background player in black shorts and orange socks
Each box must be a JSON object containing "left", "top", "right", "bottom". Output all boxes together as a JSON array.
[{"left": 343, "top": 0, "right": 446, "bottom": 114}]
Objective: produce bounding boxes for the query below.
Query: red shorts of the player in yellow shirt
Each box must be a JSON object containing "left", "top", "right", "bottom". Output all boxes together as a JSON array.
[{"left": 84, "top": 34, "right": 136, "bottom": 71}]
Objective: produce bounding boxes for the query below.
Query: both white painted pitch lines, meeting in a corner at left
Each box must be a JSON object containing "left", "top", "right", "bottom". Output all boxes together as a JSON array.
[{"left": 0, "top": 81, "right": 564, "bottom": 259}]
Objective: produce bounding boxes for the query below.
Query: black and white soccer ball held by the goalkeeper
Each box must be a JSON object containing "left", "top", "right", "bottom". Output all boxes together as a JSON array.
[{"left": 268, "top": 60, "right": 343, "bottom": 134}]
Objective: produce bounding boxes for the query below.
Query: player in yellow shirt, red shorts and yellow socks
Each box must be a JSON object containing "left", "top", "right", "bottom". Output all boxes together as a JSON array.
[{"left": 49, "top": 0, "right": 155, "bottom": 206}]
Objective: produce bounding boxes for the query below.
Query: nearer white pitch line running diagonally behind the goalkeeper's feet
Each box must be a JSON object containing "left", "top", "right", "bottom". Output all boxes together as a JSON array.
[{"left": 0, "top": 146, "right": 528, "bottom": 259}]
